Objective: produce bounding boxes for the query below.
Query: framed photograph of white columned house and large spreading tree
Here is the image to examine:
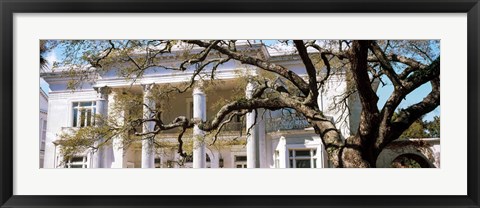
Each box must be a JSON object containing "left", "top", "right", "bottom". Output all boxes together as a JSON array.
[{"left": 38, "top": 39, "right": 445, "bottom": 169}]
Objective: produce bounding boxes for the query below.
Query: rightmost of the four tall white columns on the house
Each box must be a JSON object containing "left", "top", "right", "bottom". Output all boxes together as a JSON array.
[{"left": 245, "top": 82, "right": 260, "bottom": 168}]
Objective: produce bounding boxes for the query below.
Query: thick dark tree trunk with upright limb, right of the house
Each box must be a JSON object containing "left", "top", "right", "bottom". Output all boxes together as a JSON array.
[{"left": 316, "top": 41, "right": 379, "bottom": 168}]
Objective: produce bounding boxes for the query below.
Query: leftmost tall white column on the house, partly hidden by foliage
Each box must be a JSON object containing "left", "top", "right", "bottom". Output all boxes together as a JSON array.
[{"left": 92, "top": 86, "right": 110, "bottom": 168}]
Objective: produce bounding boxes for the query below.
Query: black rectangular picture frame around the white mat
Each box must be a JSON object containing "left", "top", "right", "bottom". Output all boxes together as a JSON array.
[{"left": 0, "top": 0, "right": 480, "bottom": 207}]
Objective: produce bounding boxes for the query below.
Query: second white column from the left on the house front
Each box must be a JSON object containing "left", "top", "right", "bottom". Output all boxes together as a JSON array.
[{"left": 142, "top": 84, "right": 155, "bottom": 168}]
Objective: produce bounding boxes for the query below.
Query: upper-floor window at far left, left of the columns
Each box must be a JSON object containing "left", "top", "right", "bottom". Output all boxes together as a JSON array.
[{"left": 72, "top": 101, "right": 96, "bottom": 127}]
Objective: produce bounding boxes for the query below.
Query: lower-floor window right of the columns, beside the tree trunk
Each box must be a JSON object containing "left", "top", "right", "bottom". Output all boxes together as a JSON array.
[{"left": 288, "top": 149, "right": 317, "bottom": 168}]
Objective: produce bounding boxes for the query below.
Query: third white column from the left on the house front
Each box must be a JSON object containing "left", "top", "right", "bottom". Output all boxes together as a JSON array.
[{"left": 193, "top": 87, "right": 205, "bottom": 168}]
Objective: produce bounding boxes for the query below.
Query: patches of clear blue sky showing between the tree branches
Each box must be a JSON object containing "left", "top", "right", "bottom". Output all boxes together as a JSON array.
[{"left": 40, "top": 40, "right": 440, "bottom": 121}]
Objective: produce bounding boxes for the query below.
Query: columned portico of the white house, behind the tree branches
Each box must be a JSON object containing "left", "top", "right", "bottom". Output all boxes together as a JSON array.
[{"left": 58, "top": 77, "right": 267, "bottom": 168}]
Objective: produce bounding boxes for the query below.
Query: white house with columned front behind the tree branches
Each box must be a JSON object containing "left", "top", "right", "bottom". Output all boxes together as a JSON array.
[{"left": 41, "top": 43, "right": 438, "bottom": 168}]
